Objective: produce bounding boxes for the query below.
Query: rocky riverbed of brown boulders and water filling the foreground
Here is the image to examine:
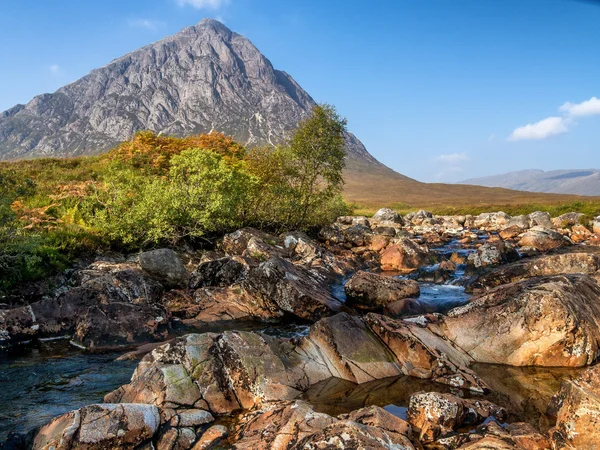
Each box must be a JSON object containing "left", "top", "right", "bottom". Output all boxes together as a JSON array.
[{"left": 0, "top": 209, "right": 600, "bottom": 450}]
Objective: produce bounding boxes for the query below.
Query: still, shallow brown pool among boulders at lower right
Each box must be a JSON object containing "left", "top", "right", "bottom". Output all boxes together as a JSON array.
[{"left": 302, "top": 364, "right": 579, "bottom": 431}]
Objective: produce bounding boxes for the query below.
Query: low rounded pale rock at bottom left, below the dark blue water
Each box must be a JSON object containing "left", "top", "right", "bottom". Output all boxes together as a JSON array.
[{"left": 33, "top": 404, "right": 160, "bottom": 450}]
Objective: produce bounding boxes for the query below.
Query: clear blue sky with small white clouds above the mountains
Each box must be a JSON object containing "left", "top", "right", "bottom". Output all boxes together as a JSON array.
[{"left": 0, "top": 0, "right": 600, "bottom": 182}]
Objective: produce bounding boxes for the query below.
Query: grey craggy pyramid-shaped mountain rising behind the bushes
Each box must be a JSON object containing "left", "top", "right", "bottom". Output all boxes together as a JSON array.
[{"left": 0, "top": 19, "right": 379, "bottom": 165}]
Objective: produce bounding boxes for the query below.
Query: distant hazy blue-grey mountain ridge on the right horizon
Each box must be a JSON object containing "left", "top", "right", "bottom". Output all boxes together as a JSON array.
[{"left": 461, "top": 169, "right": 600, "bottom": 196}]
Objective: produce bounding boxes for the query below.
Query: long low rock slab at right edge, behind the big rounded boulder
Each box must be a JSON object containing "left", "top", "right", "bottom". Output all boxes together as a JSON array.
[{"left": 469, "top": 246, "right": 600, "bottom": 292}]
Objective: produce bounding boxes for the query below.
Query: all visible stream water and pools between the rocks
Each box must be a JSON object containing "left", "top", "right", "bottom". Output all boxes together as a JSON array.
[{"left": 0, "top": 237, "right": 577, "bottom": 442}]
